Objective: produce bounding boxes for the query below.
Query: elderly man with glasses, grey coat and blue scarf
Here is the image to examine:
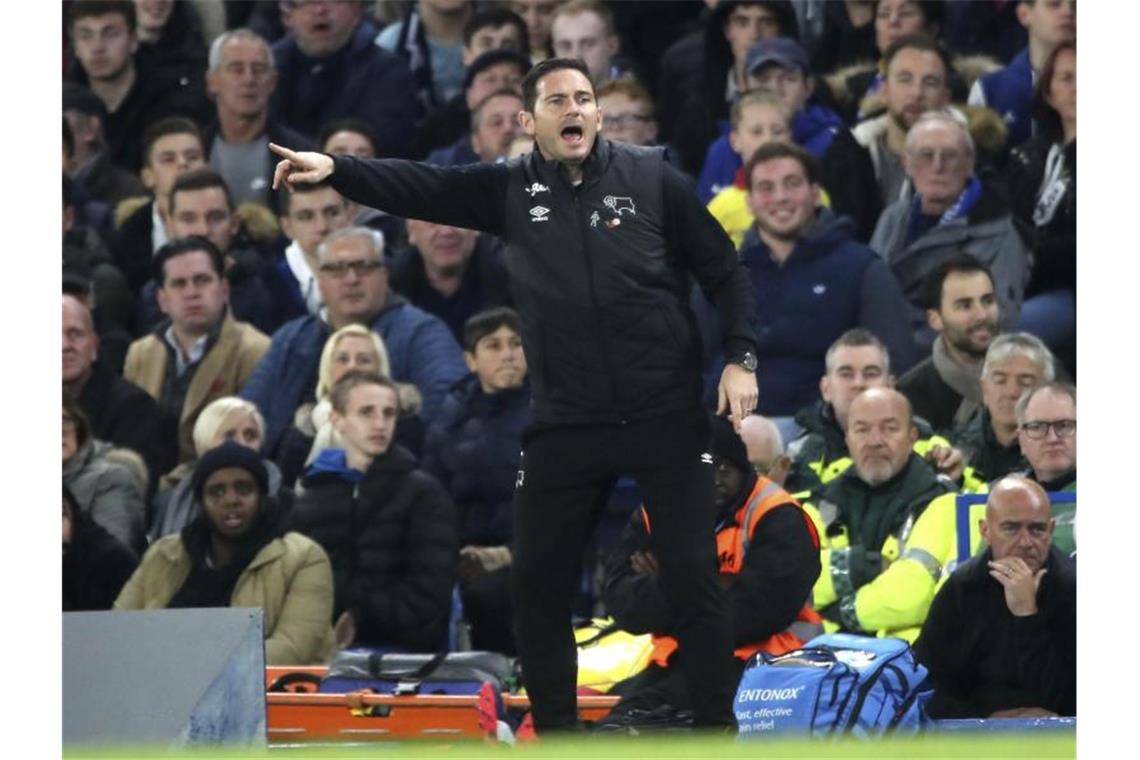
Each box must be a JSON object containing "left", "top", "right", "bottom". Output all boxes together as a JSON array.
[{"left": 871, "top": 112, "right": 1029, "bottom": 354}]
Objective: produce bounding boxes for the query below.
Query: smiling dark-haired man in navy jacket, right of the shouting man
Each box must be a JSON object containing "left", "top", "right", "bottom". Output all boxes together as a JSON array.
[{"left": 740, "top": 142, "right": 914, "bottom": 441}]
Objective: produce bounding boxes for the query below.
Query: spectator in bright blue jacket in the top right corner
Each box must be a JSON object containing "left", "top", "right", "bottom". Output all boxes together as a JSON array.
[{"left": 969, "top": 0, "right": 1076, "bottom": 154}]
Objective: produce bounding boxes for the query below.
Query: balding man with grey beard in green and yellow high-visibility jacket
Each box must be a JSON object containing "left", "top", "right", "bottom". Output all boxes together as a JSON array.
[{"left": 813, "top": 387, "right": 953, "bottom": 640}]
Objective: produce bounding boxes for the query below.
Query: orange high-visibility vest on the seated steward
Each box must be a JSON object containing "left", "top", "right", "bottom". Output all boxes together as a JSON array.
[{"left": 641, "top": 475, "right": 823, "bottom": 668}]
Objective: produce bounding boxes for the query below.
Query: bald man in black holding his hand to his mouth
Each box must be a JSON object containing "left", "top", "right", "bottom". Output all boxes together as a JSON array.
[{"left": 914, "top": 475, "right": 1076, "bottom": 718}]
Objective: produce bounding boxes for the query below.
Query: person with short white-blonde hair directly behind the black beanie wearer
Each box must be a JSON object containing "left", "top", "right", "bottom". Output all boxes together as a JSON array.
[{"left": 148, "top": 395, "right": 281, "bottom": 541}]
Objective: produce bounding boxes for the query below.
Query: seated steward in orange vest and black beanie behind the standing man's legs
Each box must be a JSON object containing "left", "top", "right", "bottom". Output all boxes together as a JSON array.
[{"left": 601, "top": 417, "right": 822, "bottom": 726}]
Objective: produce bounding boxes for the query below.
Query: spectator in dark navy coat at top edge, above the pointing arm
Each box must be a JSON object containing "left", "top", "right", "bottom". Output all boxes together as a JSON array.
[{"left": 270, "top": 2, "right": 421, "bottom": 156}]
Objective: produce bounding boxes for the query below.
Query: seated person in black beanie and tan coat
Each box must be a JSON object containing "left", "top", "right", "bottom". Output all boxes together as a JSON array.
[{"left": 114, "top": 441, "right": 336, "bottom": 665}]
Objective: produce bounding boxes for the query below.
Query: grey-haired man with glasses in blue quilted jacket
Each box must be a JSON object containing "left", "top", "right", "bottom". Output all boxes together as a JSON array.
[{"left": 242, "top": 227, "right": 466, "bottom": 458}]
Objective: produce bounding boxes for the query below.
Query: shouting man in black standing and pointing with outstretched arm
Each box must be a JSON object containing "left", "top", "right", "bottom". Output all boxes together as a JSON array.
[{"left": 271, "top": 58, "right": 757, "bottom": 730}]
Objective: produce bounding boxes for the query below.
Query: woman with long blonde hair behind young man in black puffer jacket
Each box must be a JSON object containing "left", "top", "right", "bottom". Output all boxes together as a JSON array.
[{"left": 277, "top": 325, "right": 423, "bottom": 484}]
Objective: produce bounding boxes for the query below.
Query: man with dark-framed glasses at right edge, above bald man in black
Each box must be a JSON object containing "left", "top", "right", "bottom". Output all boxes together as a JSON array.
[{"left": 1015, "top": 382, "right": 1076, "bottom": 554}]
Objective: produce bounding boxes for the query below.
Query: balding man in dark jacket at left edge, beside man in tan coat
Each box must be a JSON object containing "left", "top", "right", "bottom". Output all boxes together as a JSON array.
[{"left": 63, "top": 295, "right": 176, "bottom": 483}]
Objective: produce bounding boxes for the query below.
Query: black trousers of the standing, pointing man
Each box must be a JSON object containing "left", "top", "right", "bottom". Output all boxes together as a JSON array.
[{"left": 512, "top": 409, "right": 736, "bottom": 732}]
